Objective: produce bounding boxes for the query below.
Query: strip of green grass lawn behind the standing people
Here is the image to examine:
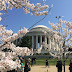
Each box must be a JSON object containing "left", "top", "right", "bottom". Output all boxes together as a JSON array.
[{"left": 23, "top": 58, "right": 70, "bottom": 65}]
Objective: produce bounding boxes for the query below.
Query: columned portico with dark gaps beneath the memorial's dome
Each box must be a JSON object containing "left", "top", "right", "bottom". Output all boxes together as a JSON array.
[{"left": 32, "top": 35, "right": 51, "bottom": 49}]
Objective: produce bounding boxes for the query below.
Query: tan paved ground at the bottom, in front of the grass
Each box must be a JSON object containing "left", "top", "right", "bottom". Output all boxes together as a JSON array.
[{"left": 30, "top": 66, "right": 69, "bottom": 72}]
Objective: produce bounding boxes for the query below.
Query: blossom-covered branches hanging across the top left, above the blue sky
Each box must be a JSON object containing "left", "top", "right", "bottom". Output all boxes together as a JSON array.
[{"left": 0, "top": 0, "right": 53, "bottom": 21}]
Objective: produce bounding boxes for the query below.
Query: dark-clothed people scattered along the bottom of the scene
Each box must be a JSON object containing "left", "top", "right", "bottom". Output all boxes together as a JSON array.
[{"left": 7, "top": 57, "right": 72, "bottom": 72}]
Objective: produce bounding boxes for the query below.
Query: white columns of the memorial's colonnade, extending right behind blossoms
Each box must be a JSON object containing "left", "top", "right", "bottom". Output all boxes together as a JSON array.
[{"left": 32, "top": 35, "right": 58, "bottom": 50}]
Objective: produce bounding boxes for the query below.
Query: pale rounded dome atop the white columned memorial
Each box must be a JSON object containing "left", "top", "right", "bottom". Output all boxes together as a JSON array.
[{"left": 26, "top": 25, "right": 50, "bottom": 36}]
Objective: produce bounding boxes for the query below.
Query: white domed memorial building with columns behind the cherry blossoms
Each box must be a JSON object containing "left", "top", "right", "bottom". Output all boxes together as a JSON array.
[{"left": 26, "top": 25, "right": 59, "bottom": 53}]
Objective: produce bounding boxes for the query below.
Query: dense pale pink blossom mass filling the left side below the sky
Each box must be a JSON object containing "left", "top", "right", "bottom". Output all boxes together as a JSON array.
[{"left": 0, "top": 25, "right": 33, "bottom": 72}]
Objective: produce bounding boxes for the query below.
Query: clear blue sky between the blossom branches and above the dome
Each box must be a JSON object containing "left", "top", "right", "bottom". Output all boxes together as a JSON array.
[{"left": 0, "top": 0, "right": 72, "bottom": 33}]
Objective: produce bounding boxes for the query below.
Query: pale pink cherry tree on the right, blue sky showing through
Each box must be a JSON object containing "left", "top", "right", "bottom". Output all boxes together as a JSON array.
[{"left": 49, "top": 19, "right": 72, "bottom": 56}]
